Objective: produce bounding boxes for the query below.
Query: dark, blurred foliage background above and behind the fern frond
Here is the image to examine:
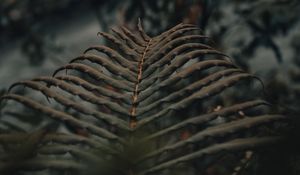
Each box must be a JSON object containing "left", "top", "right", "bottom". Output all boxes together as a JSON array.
[{"left": 0, "top": 0, "right": 300, "bottom": 175}]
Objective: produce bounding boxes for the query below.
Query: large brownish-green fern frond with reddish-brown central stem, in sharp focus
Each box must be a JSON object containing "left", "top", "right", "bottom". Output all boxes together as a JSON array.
[{"left": 0, "top": 19, "right": 285, "bottom": 175}]
